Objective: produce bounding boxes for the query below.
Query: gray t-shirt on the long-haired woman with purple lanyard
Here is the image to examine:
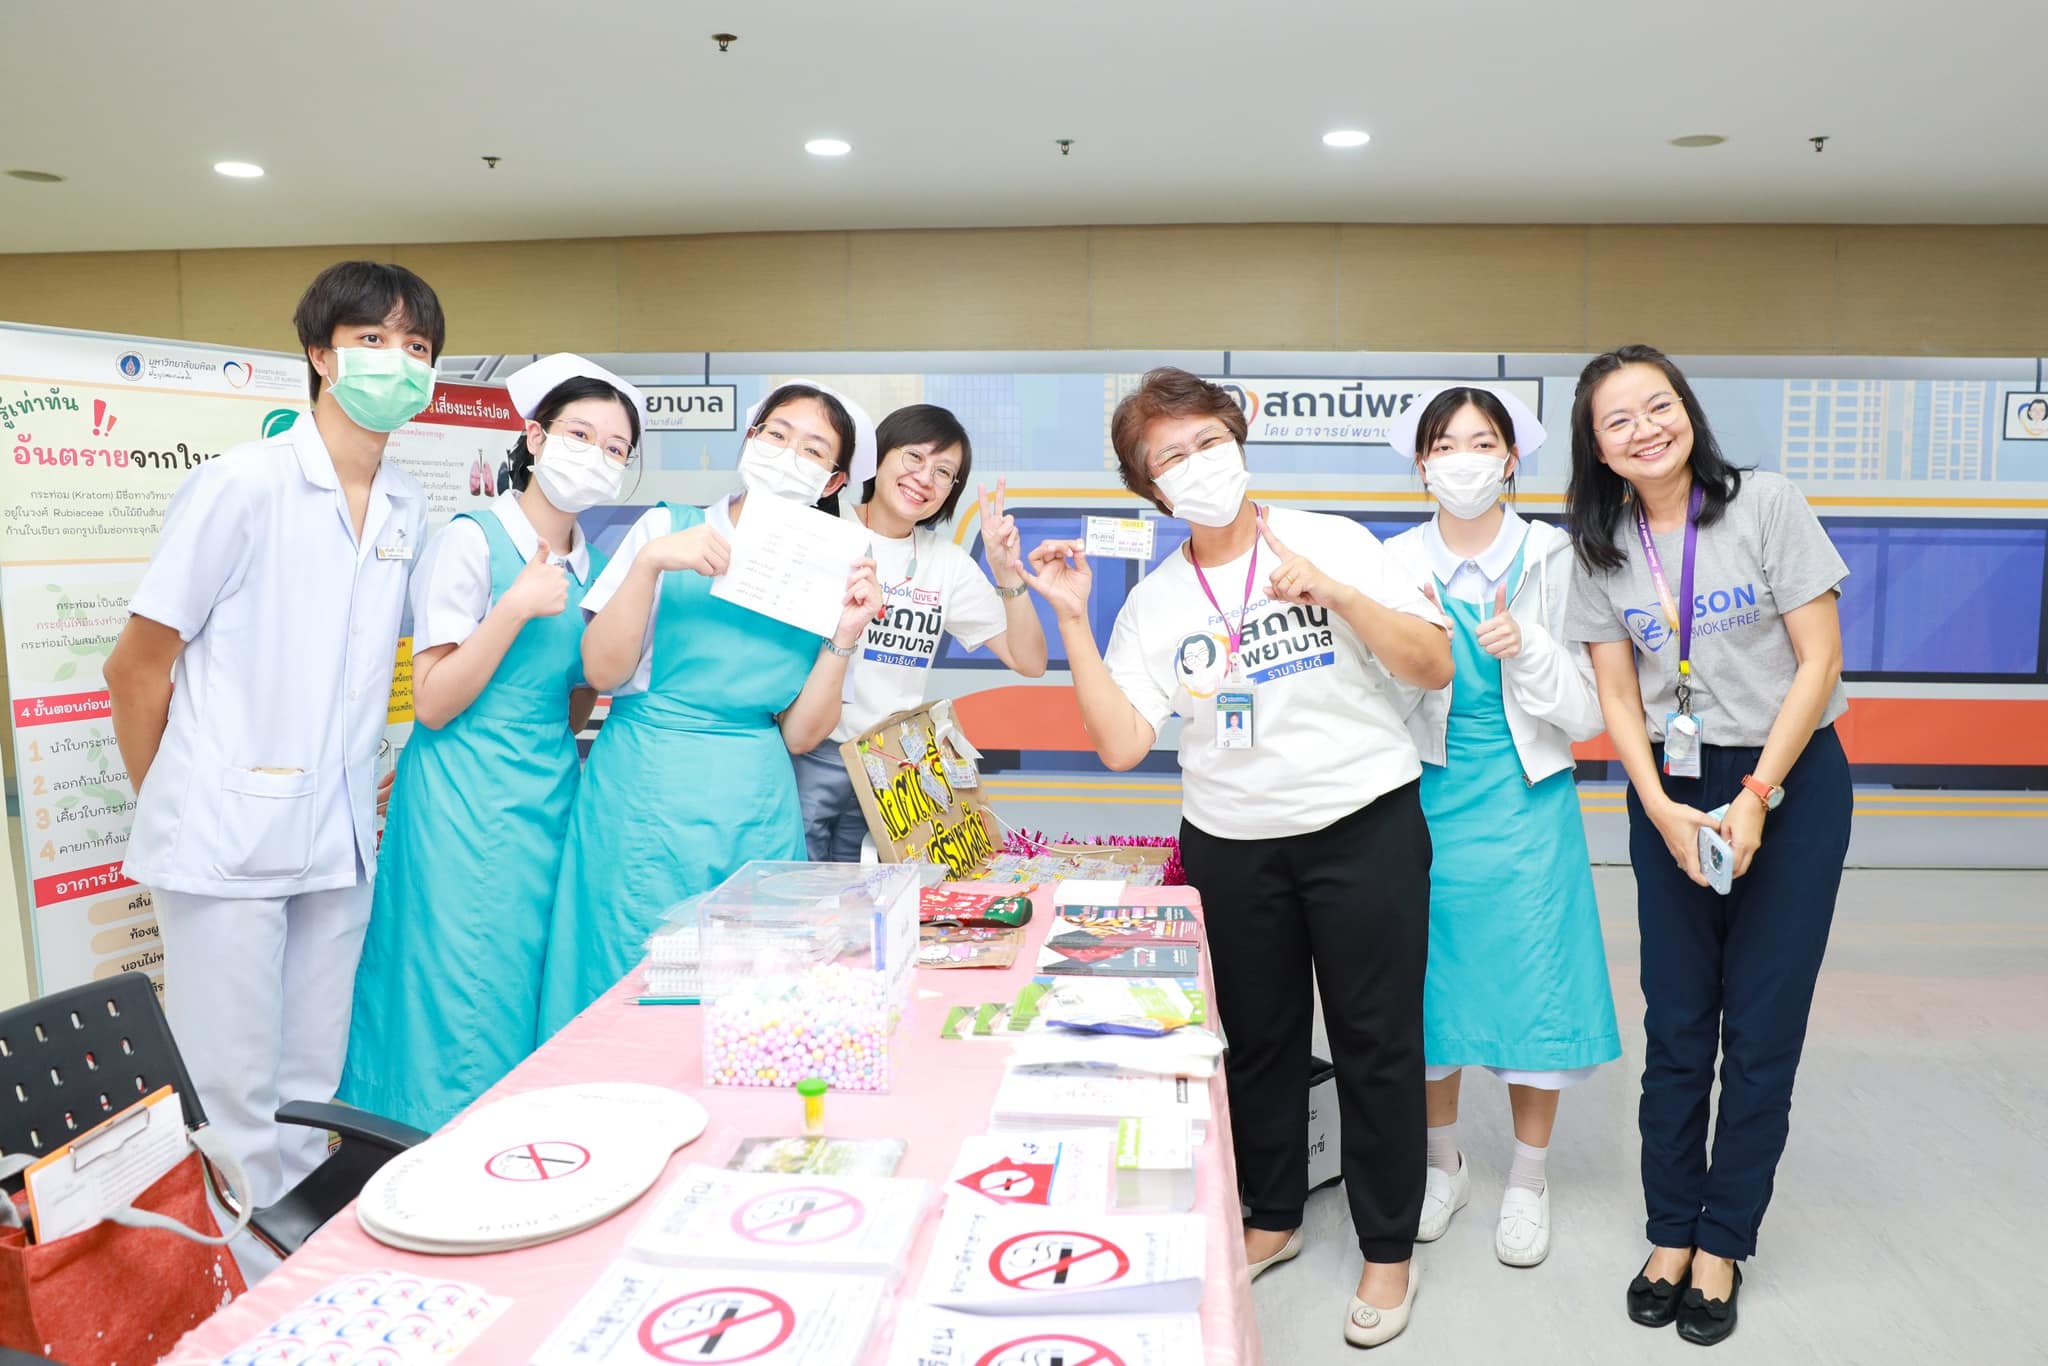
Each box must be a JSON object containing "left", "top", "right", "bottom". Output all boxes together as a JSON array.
[{"left": 1565, "top": 469, "right": 1849, "bottom": 748}]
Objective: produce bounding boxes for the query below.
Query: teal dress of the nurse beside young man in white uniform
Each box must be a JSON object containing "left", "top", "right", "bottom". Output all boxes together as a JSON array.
[{"left": 340, "top": 508, "right": 604, "bottom": 1128}]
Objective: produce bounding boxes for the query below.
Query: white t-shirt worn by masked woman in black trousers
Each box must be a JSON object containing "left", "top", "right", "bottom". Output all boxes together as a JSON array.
[{"left": 1104, "top": 508, "right": 1444, "bottom": 840}]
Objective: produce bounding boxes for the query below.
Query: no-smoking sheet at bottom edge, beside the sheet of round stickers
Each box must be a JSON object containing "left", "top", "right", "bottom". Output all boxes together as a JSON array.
[{"left": 532, "top": 1260, "right": 885, "bottom": 1366}]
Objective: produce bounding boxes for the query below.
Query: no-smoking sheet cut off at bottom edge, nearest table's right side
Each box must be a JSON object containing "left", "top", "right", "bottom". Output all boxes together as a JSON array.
[{"left": 889, "top": 1305, "right": 1202, "bottom": 1366}]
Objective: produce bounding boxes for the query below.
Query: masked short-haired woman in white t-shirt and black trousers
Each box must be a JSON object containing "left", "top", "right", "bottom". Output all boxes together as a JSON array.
[{"left": 1026, "top": 369, "right": 1452, "bottom": 1346}]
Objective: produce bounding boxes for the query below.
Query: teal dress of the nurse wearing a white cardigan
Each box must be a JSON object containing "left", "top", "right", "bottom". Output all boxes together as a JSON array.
[{"left": 1421, "top": 532, "right": 1622, "bottom": 1073}]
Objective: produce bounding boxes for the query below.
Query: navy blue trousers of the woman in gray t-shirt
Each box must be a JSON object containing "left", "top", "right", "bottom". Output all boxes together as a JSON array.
[{"left": 1628, "top": 725, "right": 1851, "bottom": 1257}]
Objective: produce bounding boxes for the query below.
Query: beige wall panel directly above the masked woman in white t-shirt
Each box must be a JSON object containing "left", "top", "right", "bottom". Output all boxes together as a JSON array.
[{"left": 1087, "top": 223, "right": 1337, "bottom": 350}]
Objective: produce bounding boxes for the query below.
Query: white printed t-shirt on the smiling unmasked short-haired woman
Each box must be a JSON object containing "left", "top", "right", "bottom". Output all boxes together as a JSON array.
[{"left": 831, "top": 526, "right": 1010, "bottom": 743}]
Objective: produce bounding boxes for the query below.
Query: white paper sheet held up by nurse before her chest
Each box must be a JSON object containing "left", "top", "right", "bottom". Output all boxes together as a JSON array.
[{"left": 711, "top": 494, "right": 868, "bottom": 635}]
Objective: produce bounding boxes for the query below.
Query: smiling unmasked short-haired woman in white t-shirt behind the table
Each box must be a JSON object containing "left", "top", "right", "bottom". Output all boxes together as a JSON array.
[{"left": 797, "top": 403, "right": 1044, "bottom": 862}]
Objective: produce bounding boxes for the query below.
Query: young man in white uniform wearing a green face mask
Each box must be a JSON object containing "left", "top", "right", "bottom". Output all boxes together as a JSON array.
[{"left": 106, "top": 260, "right": 446, "bottom": 1206}]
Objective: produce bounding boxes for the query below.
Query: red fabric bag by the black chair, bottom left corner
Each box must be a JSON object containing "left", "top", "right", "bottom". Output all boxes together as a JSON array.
[{"left": 0, "top": 1153, "right": 246, "bottom": 1366}]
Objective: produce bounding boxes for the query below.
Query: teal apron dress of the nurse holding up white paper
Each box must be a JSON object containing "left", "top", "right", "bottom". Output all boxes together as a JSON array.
[{"left": 541, "top": 494, "right": 823, "bottom": 1038}]
